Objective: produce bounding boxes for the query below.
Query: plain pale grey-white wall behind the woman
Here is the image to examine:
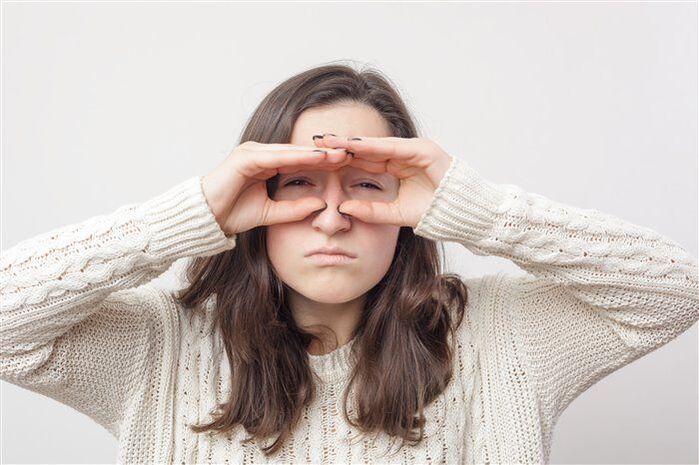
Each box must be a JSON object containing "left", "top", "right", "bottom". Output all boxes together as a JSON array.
[{"left": 1, "top": 2, "right": 698, "bottom": 463}]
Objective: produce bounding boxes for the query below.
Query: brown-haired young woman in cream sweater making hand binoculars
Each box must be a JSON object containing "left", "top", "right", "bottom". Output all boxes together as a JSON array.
[{"left": 0, "top": 65, "right": 699, "bottom": 463}]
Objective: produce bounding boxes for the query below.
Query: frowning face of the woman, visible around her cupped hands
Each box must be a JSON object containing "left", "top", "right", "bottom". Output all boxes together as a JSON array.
[{"left": 267, "top": 104, "right": 400, "bottom": 304}]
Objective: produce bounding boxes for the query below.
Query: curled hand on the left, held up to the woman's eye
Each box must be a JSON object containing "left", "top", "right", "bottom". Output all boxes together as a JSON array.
[{"left": 202, "top": 141, "right": 351, "bottom": 236}]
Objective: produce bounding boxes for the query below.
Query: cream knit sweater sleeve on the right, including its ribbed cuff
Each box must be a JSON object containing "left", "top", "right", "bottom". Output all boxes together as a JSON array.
[{"left": 414, "top": 158, "right": 699, "bottom": 428}]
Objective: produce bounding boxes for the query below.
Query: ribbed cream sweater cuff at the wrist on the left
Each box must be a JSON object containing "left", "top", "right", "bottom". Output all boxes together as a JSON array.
[{"left": 137, "top": 176, "right": 236, "bottom": 260}]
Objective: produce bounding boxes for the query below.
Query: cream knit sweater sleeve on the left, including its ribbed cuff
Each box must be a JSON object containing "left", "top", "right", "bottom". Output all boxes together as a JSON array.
[{"left": 0, "top": 176, "right": 236, "bottom": 436}]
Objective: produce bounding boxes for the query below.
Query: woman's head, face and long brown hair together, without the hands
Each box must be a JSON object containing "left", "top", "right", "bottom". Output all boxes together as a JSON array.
[{"left": 175, "top": 64, "right": 467, "bottom": 454}]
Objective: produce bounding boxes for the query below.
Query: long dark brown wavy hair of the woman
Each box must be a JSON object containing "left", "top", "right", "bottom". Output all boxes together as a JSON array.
[{"left": 175, "top": 64, "right": 467, "bottom": 456}]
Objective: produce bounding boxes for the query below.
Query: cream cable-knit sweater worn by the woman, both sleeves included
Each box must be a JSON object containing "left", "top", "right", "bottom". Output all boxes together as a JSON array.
[{"left": 0, "top": 157, "right": 699, "bottom": 464}]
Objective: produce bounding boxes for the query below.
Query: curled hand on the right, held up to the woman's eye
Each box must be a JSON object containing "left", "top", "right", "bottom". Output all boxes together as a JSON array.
[{"left": 314, "top": 134, "right": 452, "bottom": 228}]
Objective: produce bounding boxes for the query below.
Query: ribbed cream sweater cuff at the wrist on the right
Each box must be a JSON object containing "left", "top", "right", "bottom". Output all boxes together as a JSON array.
[{"left": 413, "top": 157, "right": 507, "bottom": 243}]
